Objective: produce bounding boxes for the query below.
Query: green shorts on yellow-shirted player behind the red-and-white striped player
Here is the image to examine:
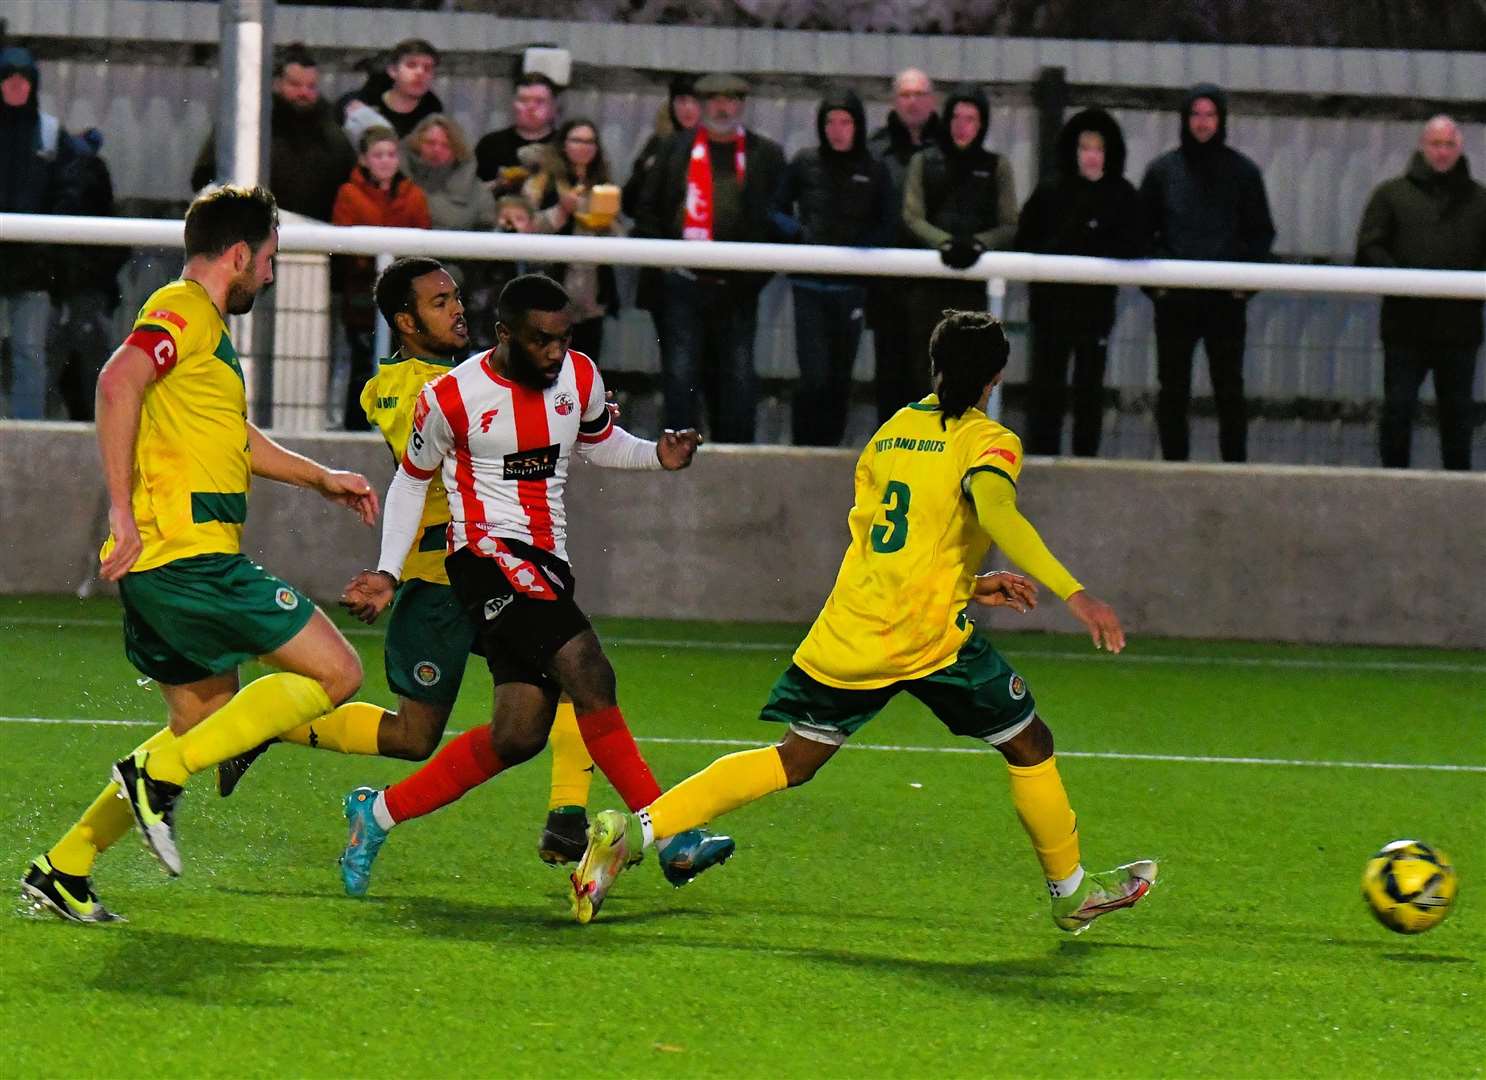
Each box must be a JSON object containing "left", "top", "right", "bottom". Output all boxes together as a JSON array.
[{"left": 382, "top": 578, "right": 476, "bottom": 706}]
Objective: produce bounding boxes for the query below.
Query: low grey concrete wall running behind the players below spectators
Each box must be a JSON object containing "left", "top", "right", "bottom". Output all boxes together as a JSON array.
[{"left": 0, "top": 422, "right": 1486, "bottom": 649}]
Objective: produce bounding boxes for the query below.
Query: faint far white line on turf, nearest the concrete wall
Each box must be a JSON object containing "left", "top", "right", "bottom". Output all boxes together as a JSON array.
[{"left": 0, "top": 615, "right": 1486, "bottom": 676}]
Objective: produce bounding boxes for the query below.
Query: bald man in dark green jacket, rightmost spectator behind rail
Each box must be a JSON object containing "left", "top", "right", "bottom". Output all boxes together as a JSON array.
[{"left": 1357, "top": 116, "right": 1486, "bottom": 469}]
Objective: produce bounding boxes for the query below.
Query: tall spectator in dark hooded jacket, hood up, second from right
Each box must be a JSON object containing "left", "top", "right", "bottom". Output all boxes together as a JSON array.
[{"left": 1140, "top": 83, "right": 1275, "bottom": 462}]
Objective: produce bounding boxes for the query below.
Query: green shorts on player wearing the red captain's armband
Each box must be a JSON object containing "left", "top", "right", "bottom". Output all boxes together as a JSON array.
[{"left": 119, "top": 554, "right": 315, "bottom": 686}]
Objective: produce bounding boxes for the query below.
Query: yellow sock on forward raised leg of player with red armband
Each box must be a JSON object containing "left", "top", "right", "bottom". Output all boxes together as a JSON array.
[{"left": 146, "top": 671, "right": 334, "bottom": 784}]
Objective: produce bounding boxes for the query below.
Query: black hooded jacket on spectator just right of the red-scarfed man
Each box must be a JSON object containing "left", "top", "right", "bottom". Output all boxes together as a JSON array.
[{"left": 774, "top": 89, "right": 898, "bottom": 282}]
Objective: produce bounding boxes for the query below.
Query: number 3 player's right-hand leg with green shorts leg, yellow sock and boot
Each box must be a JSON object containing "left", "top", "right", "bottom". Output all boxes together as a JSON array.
[{"left": 906, "top": 634, "right": 1156, "bottom": 933}]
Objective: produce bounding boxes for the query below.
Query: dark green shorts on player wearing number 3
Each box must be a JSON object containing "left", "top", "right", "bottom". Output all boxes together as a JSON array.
[{"left": 759, "top": 634, "right": 1037, "bottom": 746}]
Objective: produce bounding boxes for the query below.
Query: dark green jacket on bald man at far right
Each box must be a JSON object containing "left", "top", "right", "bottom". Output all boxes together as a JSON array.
[{"left": 1357, "top": 152, "right": 1486, "bottom": 346}]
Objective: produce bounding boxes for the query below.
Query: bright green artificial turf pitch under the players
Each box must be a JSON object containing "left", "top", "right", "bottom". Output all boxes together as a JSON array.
[{"left": 0, "top": 597, "right": 1486, "bottom": 1077}]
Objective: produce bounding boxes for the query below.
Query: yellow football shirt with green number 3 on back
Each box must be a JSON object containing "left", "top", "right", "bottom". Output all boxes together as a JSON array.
[{"left": 795, "top": 394, "right": 1022, "bottom": 689}]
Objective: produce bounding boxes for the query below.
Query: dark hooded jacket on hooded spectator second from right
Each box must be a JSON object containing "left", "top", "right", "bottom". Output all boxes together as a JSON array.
[{"left": 1140, "top": 83, "right": 1275, "bottom": 270}]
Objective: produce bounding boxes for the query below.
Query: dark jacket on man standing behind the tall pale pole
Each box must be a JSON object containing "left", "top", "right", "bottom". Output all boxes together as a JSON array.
[{"left": 190, "top": 94, "right": 357, "bottom": 221}]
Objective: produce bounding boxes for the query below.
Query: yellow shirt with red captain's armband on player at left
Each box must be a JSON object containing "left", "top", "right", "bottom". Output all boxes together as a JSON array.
[{"left": 101, "top": 279, "right": 253, "bottom": 572}]
